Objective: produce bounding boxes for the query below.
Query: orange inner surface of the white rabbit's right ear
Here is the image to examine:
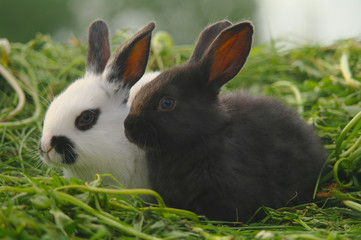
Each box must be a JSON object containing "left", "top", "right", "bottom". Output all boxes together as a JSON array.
[{"left": 123, "top": 36, "right": 150, "bottom": 84}]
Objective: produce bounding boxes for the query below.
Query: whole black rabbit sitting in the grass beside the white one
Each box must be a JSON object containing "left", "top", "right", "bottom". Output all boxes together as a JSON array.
[{"left": 124, "top": 22, "right": 325, "bottom": 221}]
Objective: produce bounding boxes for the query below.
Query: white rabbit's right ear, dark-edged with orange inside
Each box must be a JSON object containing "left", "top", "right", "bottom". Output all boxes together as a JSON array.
[{"left": 106, "top": 22, "right": 155, "bottom": 88}]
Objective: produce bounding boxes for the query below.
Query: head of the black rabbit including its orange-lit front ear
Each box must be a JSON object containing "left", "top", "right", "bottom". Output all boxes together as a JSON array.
[{"left": 124, "top": 22, "right": 253, "bottom": 150}]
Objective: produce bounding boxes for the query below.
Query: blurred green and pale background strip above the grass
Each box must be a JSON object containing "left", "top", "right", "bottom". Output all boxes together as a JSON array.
[{"left": 0, "top": 0, "right": 361, "bottom": 45}]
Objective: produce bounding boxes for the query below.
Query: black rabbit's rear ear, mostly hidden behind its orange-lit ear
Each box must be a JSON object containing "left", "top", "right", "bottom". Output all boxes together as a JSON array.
[{"left": 189, "top": 20, "right": 232, "bottom": 62}]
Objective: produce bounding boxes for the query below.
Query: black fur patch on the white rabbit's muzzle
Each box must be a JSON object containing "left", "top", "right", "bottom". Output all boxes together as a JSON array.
[{"left": 50, "top": 136, "right": 78, "bottom": 164}]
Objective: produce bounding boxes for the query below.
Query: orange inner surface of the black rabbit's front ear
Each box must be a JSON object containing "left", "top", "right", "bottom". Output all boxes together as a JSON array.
[{"left": 208, "top": 28, "right": 251, "bottom": 84}]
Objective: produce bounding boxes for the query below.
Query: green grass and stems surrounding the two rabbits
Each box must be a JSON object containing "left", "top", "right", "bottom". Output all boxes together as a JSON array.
[{"left": 0, "top": 32, "right": 361, "bottom": 240}]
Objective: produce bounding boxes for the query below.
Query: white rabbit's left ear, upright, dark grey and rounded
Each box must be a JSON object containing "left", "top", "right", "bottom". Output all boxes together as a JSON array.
[{"left": 87, "top": 20, "right": 110, "bottom": 74}]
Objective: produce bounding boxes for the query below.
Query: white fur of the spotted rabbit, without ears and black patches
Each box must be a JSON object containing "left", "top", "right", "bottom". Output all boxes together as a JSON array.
[{"left": 40, "top": 71, "right": 159, "bottom": 188}]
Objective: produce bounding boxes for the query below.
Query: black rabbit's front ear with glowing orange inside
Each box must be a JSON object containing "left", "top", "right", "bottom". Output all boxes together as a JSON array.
[{"left": 202, "top": 22, "right": 253, "bottom": 88}]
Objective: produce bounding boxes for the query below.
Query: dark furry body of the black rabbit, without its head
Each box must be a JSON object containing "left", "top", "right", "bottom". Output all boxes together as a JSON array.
[{"left": 147, "top": 90, "right": 325, "bottom": 221}]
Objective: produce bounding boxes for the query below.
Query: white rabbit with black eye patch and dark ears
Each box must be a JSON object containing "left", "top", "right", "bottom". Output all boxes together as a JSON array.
[{"left": 39, "top": 20, "right": 155, "bottom": 188}]
